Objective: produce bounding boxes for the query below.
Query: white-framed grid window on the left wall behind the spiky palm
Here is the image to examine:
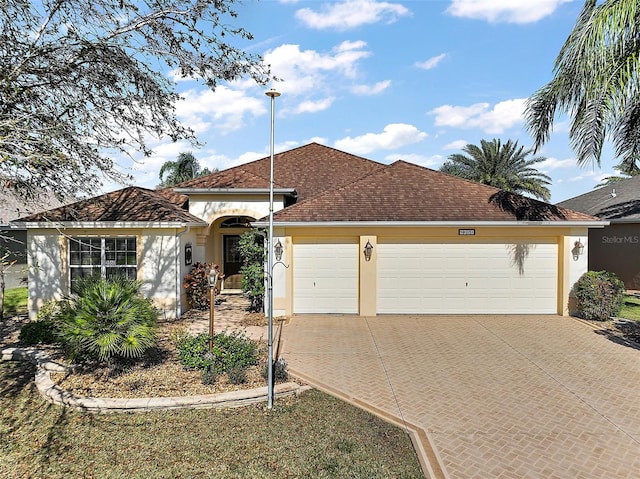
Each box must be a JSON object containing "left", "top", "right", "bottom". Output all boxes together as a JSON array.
[{"left": 69, "top": 237, "right": 138, "bottom": 291}]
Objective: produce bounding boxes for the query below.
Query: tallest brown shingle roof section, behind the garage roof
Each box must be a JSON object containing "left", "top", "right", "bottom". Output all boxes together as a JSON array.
[{"left": 168, "top": 143, "right": 384, "bottom": 201}]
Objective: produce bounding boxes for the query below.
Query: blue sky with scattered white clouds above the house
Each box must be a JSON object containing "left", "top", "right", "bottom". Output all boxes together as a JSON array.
[{"left": 112, "top": 0, "right": 616, "bottom": 203}]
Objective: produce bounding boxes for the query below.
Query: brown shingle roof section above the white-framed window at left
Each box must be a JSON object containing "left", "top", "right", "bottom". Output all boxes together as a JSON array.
[{"left": 16, "top": 186, "right": 202, "bottom": 223}]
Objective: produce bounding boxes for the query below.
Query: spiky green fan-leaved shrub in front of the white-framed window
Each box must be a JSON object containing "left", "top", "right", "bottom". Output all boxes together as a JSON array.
[{"left": 59, "top": 277, "right": 158, "bottom": 361}]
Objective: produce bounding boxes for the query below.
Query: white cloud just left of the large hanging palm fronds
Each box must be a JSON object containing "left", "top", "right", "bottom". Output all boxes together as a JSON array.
[{"left": 429, "top": 98, "right": 526, "bottom": 134}]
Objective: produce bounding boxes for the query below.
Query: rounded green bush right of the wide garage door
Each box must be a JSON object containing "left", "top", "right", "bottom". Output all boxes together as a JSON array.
[{"left": 574, "top": 271, "right": 625, "bottom": 321}]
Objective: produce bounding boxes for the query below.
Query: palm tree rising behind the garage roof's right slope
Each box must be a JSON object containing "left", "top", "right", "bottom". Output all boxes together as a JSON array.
[{"left": 440, "top": 138, "right": 551, "bottom": 201}]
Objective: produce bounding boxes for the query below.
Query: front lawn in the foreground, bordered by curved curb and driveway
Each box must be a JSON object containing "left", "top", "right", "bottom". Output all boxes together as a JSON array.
[{"left": 0, "top": 363, "right": 423, "bottom": 479}]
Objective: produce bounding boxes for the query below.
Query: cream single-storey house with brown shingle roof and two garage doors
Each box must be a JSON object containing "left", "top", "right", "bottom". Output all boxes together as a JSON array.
[{"left": 17, "top": 143, "right": 607, "bottom": 317}]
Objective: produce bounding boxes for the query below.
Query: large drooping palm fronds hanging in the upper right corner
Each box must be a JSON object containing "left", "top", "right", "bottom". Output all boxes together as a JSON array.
[{"left": 526, "top": 0, "right": 640, "bottom": 169}]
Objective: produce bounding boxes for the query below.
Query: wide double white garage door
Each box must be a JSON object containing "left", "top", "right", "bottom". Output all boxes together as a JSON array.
[{"left": 377, "top": 240, "right": 558, "bottom": 314}]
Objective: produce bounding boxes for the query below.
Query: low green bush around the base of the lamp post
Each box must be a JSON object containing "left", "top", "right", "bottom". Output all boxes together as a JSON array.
[{"left": 178, "top": 332, "right": 258, "bottom": 376}]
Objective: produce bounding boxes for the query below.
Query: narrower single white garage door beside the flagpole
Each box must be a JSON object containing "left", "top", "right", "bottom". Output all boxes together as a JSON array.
[{"left": 293, "top": 239, "right": 359, "bottom": 314}]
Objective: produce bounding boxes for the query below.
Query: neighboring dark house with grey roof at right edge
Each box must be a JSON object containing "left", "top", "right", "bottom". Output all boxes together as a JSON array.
[{"left": 558, "top": 176, "right": 640, "bottom": 289}]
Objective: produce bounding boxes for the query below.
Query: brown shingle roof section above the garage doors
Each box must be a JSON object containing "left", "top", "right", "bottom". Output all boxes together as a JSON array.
[{"left": 274, "top": 161, "right": 597, "bottom": 222}]
